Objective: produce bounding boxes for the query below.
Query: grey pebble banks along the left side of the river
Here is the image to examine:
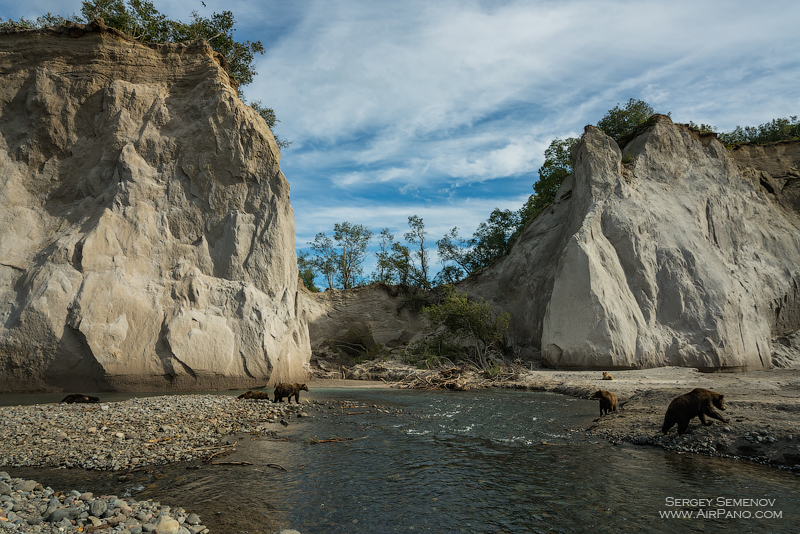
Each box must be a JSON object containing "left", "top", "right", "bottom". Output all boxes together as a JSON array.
[{"left": 0, "top": 395, "right": 307, "bottom": 534}]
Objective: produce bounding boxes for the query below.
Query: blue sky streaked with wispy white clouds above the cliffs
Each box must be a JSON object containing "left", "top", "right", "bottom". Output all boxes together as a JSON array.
[{"left": 0, "top": 0, "right": 800, "bottom": 288}]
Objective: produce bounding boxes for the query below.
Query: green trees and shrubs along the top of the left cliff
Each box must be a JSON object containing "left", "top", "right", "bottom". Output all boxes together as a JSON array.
[{"left": 0, "top": 0, "right": 291, "bottom": 148}]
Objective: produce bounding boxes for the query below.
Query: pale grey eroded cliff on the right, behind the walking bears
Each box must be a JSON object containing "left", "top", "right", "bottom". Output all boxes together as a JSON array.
[{"left": 460, "top": 116, "right": 800, "bottom": 370}]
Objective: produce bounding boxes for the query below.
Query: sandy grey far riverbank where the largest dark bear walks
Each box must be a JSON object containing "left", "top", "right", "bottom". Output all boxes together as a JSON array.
[{"left": 309, "top": 361, "right": 800, "bottom": 474}]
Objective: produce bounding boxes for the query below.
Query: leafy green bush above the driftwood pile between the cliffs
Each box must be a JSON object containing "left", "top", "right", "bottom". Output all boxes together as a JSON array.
[{"left": 422, "top": 285, "right": 510, "bottom": 369}]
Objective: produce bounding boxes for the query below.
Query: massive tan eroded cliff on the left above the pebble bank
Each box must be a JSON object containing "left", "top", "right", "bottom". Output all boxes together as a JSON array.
[{"left": 0, "top": 24, "right": 310, "bottom": 391}]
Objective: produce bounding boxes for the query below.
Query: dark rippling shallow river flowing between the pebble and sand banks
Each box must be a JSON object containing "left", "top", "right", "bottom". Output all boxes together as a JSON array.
[{"left": 9, "top": 388, "right": 800, "bottom": 534}]
